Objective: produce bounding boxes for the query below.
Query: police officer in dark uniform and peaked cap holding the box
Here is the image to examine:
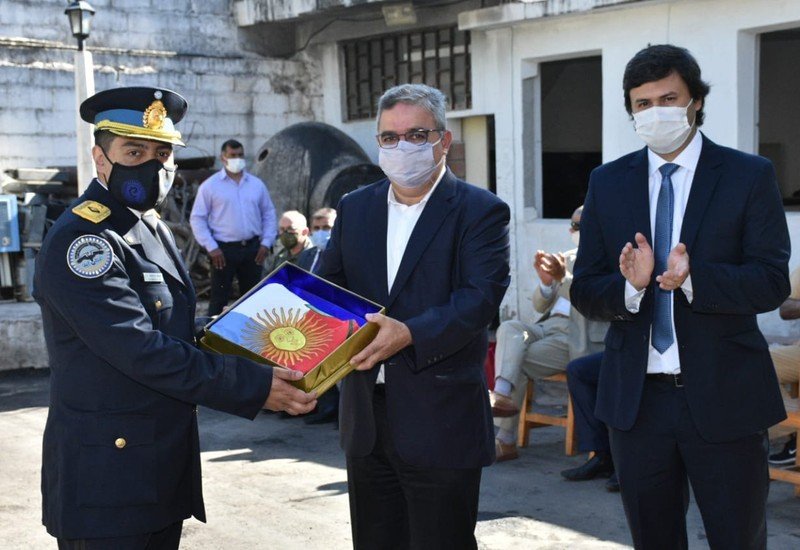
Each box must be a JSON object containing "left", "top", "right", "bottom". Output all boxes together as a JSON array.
[{"left": 34, "top": 88, "right": 316, "bottom": 550}]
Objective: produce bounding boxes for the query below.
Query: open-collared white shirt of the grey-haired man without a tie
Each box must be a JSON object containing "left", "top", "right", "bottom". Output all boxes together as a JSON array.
[{"left": 376, "top": 166, "right": 445, "bottom": 384}]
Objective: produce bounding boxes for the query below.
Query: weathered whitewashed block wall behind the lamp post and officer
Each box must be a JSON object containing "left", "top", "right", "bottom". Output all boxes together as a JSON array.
[{"left": 0, "top": 0, "right": 323, "bottom": 177}]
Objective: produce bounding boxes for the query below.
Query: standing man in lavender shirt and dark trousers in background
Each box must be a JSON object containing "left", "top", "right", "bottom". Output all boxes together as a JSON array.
[{"left": 189, "top": 139, "right": 277, "bottom": 316}]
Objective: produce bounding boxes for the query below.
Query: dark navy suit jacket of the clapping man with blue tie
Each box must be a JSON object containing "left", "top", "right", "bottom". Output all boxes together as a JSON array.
[{"left": 571, "top": 136, "right": 790, "bottom": 442}]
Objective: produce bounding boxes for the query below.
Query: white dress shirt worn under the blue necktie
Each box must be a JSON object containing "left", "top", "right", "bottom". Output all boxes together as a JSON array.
[{"left": 625, "top": 131, "right": 703, "bottom": 374}]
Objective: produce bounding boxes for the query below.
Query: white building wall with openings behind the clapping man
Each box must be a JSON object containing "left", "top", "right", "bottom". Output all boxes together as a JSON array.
[{"left": 460, "top": 0, "right": 800, "bottom": 335}]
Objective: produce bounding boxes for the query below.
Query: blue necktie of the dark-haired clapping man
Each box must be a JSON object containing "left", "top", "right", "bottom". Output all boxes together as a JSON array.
[{"left": 652, "top": 163, "right": 678, "bottom": 353}]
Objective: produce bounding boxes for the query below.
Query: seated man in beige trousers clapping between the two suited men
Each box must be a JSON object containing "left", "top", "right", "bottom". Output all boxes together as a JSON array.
[{"left": 490, "top": 207, "right": 608, "bottom": 462}]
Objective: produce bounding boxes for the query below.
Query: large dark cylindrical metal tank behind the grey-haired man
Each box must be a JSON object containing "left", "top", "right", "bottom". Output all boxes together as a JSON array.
[{"left": 252, "top": 122, "right": 384, "bottom": 217}]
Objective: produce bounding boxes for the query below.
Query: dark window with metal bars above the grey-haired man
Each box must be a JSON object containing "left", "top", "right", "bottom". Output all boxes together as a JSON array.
[{"left": 342, "top": 26, "right": 472, "bottom": 120}]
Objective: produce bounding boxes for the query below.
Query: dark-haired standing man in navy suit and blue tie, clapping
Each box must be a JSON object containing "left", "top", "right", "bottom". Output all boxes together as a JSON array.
[{"left": 572, "top": 45, "right": 789, "bottom": 550}]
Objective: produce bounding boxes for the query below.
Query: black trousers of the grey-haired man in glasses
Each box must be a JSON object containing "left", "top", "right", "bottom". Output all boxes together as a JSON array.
[{"left": 347, "top": 389, "right": 481, "bottom": 550}]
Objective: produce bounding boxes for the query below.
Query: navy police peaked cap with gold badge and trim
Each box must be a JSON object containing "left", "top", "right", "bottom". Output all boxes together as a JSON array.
[{"left": 80, "top": 87, "right": 188, "bottom": 145}]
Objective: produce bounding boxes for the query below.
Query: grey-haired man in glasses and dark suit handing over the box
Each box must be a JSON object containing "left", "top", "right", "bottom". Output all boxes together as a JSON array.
[{"left": 320, "top": 84, "right": 509, "bottom": 550}]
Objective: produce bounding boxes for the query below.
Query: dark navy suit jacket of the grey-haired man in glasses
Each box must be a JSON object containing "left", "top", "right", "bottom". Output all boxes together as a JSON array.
[{"left": 319, "top": 171, "right": 509, "bottom": 468}]
